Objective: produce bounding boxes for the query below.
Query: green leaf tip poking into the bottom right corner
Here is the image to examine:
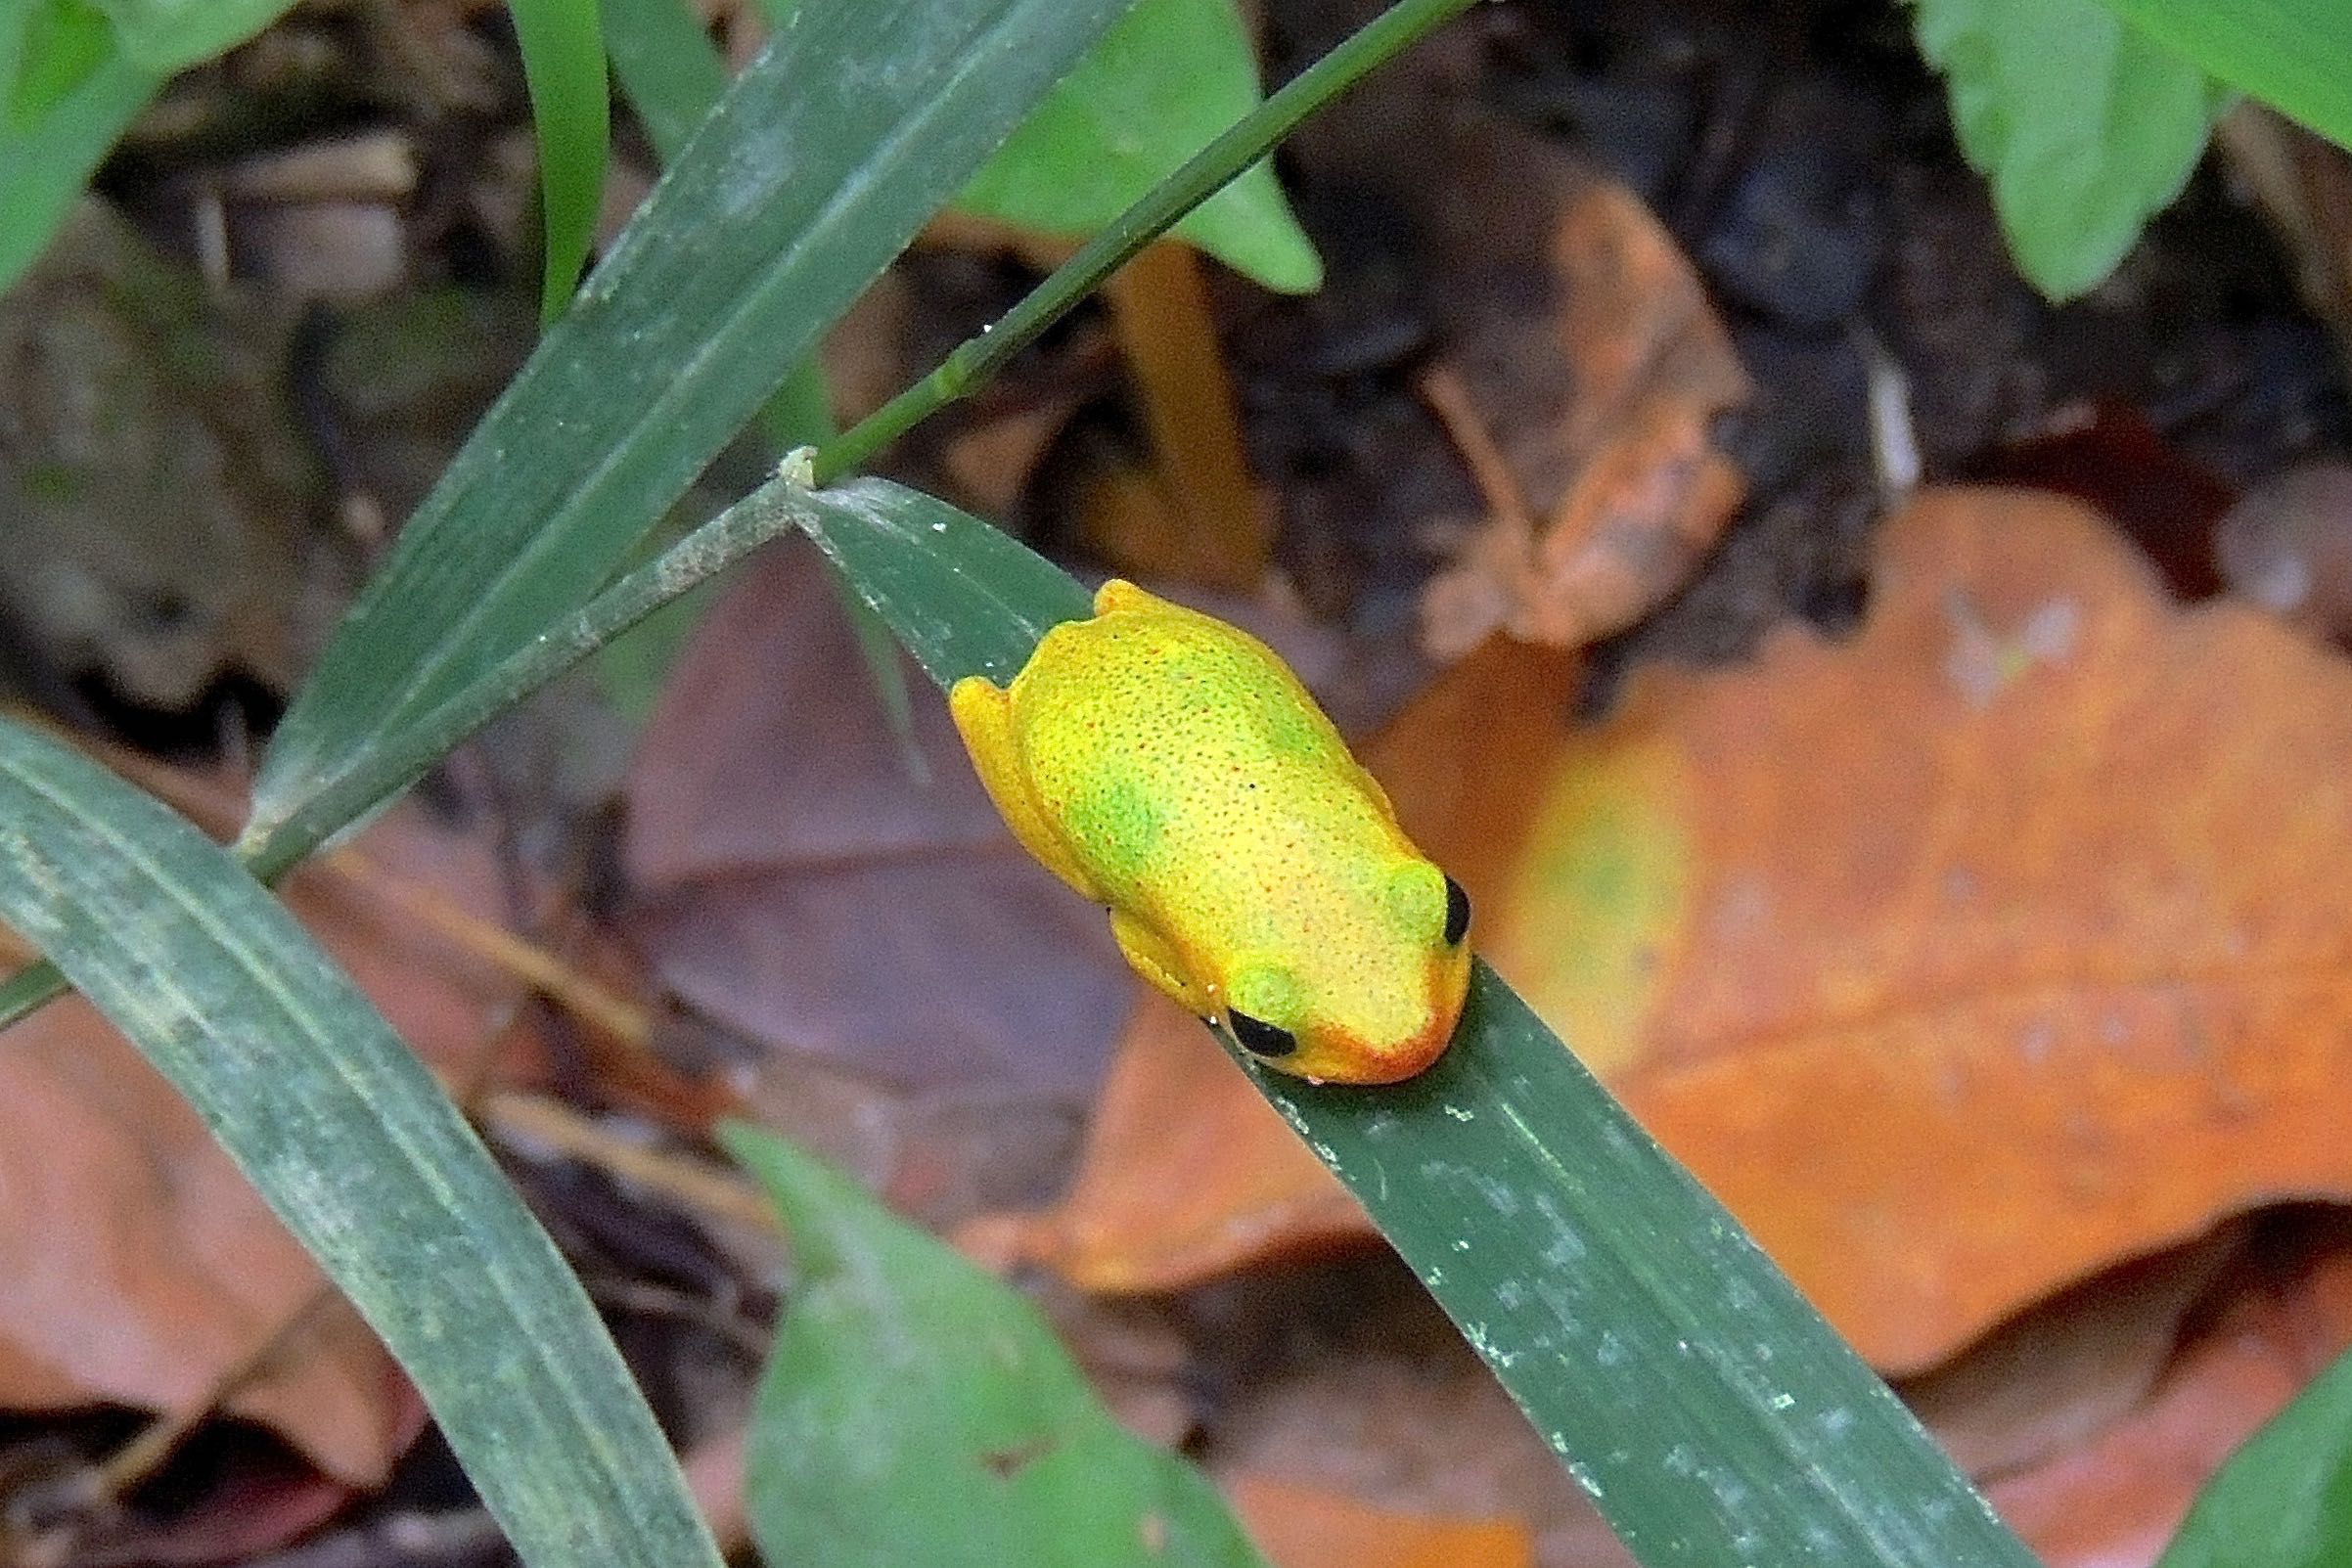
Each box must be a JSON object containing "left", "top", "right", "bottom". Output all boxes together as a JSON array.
[{"left": 2156, "top": 1354, "right": 2352, "bottom": 1568}]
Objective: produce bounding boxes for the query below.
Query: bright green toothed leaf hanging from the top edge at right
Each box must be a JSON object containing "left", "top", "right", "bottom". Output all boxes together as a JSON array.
[{"left": 1912, "top": 0, "right": 2228, "bottom": 301}]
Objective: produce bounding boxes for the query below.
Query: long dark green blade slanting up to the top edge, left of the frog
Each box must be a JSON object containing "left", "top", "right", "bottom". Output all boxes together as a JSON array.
[{"left": 254, "top": 0, "right": 1138, "bottom": 846}]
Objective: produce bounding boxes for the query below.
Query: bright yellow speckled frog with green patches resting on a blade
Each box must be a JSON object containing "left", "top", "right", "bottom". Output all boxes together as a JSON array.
[{"left": 950, "top": 581, "right": 1470, "bottom": 1084}]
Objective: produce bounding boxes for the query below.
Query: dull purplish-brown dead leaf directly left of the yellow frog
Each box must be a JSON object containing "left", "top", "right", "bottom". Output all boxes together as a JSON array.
[{"left": 628, "top": 535, "right": 1129, "bottom": 1094}]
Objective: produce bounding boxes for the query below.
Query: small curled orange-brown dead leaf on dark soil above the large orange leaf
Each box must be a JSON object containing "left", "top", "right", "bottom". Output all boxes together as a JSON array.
[{"left": 1423, "top": 127, "right": 1750, "bottom": 658}]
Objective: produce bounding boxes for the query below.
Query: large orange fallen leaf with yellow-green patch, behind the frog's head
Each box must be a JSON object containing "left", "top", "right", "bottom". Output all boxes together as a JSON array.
[{"left": 992, "top": 491, "right": 2352, "bottom": 1370}]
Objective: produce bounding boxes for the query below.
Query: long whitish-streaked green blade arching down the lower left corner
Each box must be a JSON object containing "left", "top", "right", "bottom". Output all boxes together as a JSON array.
[{"left": 0, "top": 722, "right": 717, "bottom": 1568}]
